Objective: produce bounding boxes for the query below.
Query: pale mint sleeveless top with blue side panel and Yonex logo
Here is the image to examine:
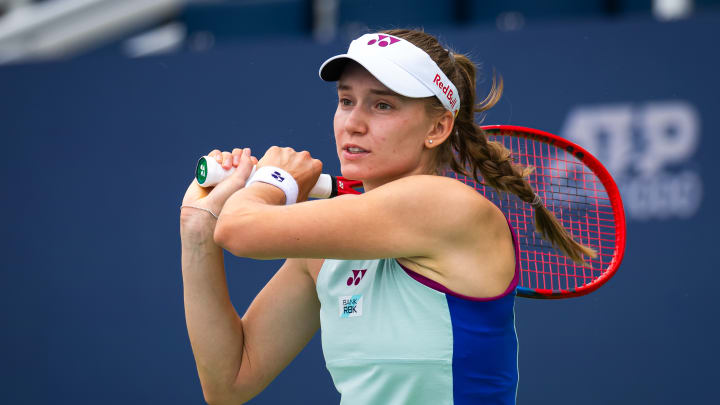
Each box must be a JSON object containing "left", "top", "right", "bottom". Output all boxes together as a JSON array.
[{"left": 317, "top": 251, "right": 518, "bottom": 405}]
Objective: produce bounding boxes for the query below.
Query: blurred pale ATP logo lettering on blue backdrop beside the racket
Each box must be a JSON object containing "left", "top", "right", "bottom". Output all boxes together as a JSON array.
[{"left": 562, "top": 100, "right": 703, "bottom": 220}]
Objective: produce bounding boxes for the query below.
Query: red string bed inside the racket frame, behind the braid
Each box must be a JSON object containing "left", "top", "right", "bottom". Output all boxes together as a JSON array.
[{"left": 446, "top": 133, "right": 616, "bottom": 291}]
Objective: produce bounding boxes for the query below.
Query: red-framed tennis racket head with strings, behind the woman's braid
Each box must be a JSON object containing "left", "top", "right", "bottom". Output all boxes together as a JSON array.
[{"left": 446, "top": 125, "right": 625, "bottom": 299}]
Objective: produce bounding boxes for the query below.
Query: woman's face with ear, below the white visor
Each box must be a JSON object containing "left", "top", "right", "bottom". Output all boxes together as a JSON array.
[{"left": 334, "top": 63, "right": 434, "bottom": 191}]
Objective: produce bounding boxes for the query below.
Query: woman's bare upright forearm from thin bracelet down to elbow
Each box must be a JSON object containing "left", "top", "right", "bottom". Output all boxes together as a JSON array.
[{"left": 181, "top": 212, "right": 243, "bottom": 403}]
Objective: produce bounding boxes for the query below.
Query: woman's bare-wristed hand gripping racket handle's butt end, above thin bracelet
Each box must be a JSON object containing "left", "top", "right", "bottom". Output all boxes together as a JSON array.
[{"left": 180, "top": 148, "right": 257, "bottom": 230}]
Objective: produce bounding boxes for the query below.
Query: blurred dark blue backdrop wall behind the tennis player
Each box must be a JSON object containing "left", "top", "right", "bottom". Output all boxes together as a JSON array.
[{"left": 0, "top": 0, "right": 720, "bottom": 404}]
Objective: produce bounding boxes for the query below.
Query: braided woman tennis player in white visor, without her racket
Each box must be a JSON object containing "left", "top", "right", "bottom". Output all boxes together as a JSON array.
[{"left": 181, "top": 30, "right": 588, "bottom": 405}]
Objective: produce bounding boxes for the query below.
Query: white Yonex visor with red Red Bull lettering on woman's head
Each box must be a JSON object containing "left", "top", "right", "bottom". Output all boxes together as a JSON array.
[{"left": 320, "top": 34, "right": 460, "bottom": 116}]
